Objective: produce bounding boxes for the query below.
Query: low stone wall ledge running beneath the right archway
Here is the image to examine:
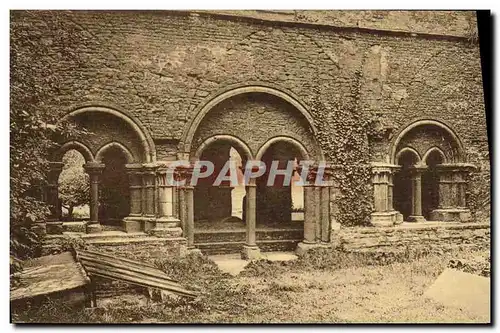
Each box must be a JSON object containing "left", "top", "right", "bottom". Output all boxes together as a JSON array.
[{"left": 334, "top": 223, "right": 491, "bottom": 252}]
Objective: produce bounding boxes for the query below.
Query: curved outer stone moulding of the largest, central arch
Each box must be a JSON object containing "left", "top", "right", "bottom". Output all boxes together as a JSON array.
[{"left": 179, "top": 82, "right": 319, "bottom": 154}]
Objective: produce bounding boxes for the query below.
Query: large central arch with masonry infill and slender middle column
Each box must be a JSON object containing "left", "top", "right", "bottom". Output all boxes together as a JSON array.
[{"left": 184, "top": 85, "right": 324, "bottom": 257}]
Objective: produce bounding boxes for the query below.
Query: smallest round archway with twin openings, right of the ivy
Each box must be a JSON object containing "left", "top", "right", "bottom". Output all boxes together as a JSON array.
[{"left": 372, "top": 120, "right": 474, "bottom": 225}]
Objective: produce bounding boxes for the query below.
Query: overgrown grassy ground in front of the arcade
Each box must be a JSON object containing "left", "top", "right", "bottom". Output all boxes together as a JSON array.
[{"left": 12, "top": 246, "right": 489, "bottom": 323}]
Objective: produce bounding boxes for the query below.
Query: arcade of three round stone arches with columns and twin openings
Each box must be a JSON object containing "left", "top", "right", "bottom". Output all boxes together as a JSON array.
[{"left": 42, "top": 100, "right": 474, "bottom": 258}]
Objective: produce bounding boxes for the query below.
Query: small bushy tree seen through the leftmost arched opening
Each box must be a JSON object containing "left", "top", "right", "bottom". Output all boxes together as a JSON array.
[{"left": 59, "top": 150, "right": 90, "bottom": 218}]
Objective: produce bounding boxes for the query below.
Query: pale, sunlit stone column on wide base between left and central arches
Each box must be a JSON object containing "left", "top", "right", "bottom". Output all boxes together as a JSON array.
[{"left": 151, "top": 166, "right": 182, "bottom": 237}]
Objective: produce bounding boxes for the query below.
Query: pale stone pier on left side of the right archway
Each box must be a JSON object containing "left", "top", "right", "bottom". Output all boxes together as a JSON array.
[{"left": 371, "top": 162, "right": 402, "bottom": 227}]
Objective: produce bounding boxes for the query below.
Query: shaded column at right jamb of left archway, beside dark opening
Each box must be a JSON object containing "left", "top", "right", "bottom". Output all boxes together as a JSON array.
[{"left": 123, "top": 164, "right": 145, "bottom": 232}]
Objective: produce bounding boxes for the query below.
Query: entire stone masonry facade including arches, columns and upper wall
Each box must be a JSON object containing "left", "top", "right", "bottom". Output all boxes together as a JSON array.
[{"left": 11, "top": 11, "right": 490, "bottom": 254}]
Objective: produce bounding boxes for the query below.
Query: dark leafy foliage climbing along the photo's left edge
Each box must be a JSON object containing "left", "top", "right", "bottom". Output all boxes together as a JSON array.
[{"left": 10, "top": 11, "right": 88, "bottom": 258}]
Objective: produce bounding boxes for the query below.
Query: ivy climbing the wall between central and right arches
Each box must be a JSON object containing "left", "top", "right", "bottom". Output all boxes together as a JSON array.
[{"left": 309, "top": 72, "right": 373, "bottom": 226}]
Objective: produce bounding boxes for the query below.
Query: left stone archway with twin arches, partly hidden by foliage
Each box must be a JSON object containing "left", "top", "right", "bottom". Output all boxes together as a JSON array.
[{"left": 48, "top": 105, "right": 156, "bottom": 232}]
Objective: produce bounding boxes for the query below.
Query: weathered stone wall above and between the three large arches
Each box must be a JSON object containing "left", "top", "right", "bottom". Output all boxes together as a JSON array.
[{"left": 11, "top": 11, "right": 489, "bottom": 225}]
